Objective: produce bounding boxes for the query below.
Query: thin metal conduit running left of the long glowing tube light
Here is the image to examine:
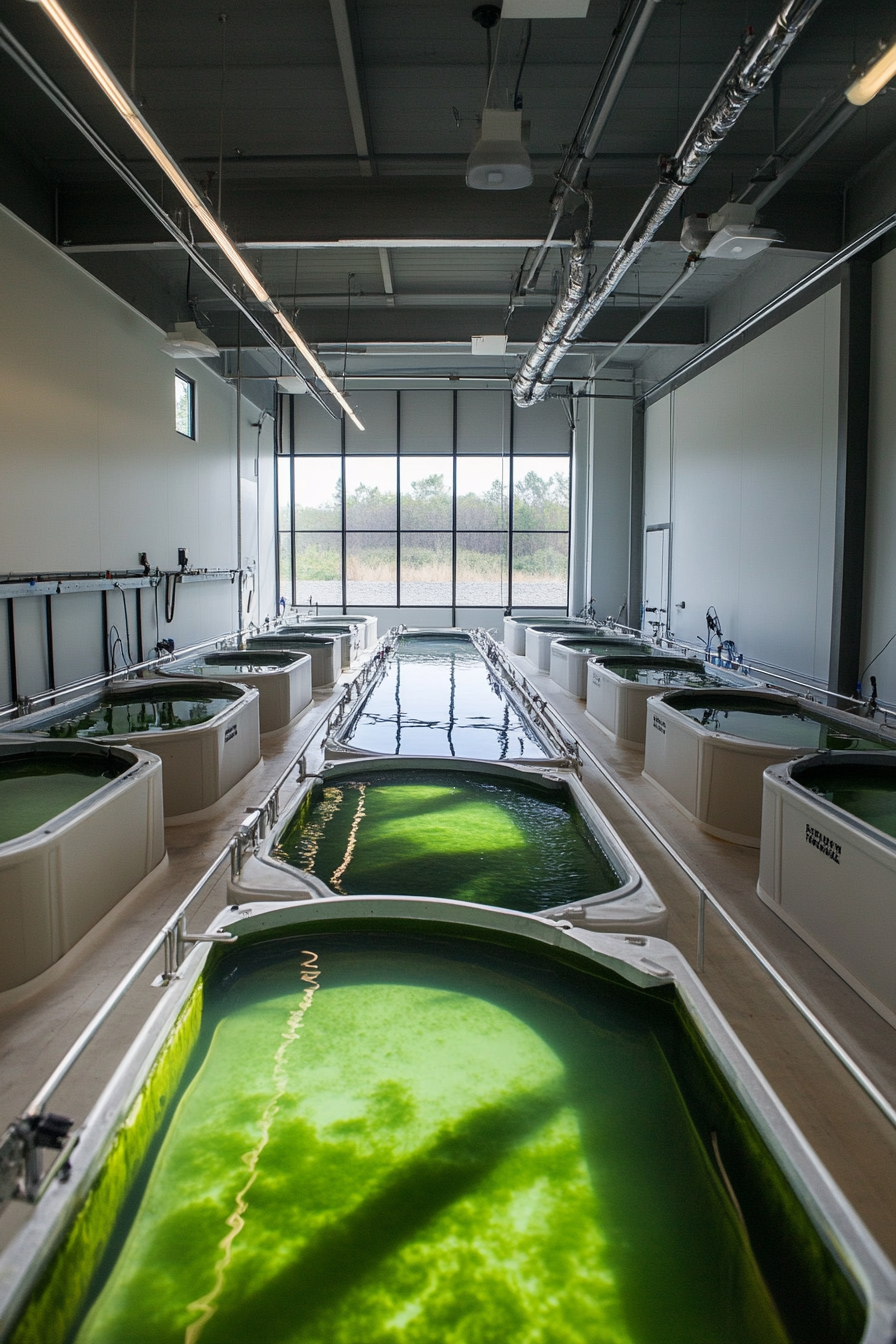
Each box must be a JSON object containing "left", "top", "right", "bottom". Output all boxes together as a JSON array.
[{"left": 0, "top": 23, "right": 341, "bottom": 419}]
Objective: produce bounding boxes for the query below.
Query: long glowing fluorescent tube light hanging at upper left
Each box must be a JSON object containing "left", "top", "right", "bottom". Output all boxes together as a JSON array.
[{"left": 28, "top": 0, "right": 364, "bottom": 429}]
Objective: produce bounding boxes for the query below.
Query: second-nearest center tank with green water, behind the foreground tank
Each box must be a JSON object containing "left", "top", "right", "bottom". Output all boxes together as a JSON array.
[{"left": 228, "top": 757, "right": 666, "bottom": 937}]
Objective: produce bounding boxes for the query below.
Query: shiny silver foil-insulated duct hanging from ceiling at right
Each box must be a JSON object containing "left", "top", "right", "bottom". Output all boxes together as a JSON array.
[{"left": 510, "top": 0, "right": 821, "bottom": 407}]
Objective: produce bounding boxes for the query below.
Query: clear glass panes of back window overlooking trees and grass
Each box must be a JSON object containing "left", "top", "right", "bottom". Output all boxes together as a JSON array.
[{"left": 277, "top": 453, "right": 570, "bottom": 607}]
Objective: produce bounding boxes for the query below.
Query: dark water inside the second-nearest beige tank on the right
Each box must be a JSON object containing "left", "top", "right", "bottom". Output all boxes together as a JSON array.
[{"left": 669, "top": 691, "right": 896, "bottom": 751}]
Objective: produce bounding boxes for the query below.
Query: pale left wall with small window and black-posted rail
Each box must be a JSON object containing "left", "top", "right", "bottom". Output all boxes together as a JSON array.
[{"left": 0, "top": 208, "right": 274, "bottom": 703}]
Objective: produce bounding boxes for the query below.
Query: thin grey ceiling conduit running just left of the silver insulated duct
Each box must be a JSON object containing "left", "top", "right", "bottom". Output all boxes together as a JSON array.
[{"left": 520, "top": 0, "right": 660, "bottom": 294}]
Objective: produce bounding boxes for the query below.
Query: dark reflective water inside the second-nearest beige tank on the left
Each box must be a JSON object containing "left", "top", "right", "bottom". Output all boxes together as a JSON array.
[{"left": 27, "top": 684, "right": 236, "bottom": 738}]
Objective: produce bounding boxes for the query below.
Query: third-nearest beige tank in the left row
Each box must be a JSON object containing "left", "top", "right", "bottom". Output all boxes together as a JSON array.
[{"left": 160, "top": 649, "right": 312, "bottom": 734}]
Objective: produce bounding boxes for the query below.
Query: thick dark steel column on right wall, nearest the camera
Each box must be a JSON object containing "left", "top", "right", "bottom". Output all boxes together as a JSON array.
[{"left": 827, "top": 257, "right": 872, "bottom": 695}]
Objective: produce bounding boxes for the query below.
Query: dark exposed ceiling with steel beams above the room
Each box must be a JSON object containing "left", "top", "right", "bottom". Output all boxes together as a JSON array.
[{"left": 0, "top": 0, "right": 896, "bottom": 395}]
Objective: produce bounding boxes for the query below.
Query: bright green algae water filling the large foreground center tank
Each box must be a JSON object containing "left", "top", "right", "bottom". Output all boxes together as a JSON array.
[{"left": 70, "top": 931, "right": 827, "bottom": 1344}]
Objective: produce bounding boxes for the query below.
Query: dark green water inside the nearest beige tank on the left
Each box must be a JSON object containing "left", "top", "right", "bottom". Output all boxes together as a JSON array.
[{"left": 0, "top": 753, "right": 128, "bottom": 844}]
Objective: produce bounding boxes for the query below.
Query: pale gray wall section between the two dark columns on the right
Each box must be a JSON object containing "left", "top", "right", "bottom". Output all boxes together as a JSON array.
[{"left": 645, "top": 289, "right": 840, "bottom": 683}]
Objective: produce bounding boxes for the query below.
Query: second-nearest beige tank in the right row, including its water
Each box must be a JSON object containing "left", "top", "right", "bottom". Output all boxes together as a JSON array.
[{"left": 643, "top": 689, "right": 896, "bottom": 848}]
